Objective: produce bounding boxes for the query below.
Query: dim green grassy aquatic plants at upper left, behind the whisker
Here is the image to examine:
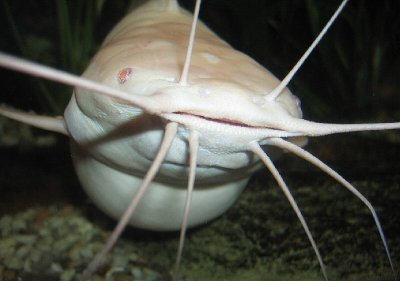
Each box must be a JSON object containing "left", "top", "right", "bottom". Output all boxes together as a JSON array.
[{"left": 1, "top": 0, "right": 111, "bottom": 114}]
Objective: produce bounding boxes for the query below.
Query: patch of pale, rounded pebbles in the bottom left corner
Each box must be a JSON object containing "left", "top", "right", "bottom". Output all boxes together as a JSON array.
[{"left": 0, "top": 205, "right": 163, "bottom": 281}]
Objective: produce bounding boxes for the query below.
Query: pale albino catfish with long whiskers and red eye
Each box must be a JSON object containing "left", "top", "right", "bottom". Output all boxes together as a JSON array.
[{"left": 0, "top": 0, "right": 400, "bottom": 280}]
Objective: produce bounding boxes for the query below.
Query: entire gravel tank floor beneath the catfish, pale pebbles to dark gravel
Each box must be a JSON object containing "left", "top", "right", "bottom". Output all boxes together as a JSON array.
[{"left": 0, "top": 175, "right": 400, "bottom": 281}]
